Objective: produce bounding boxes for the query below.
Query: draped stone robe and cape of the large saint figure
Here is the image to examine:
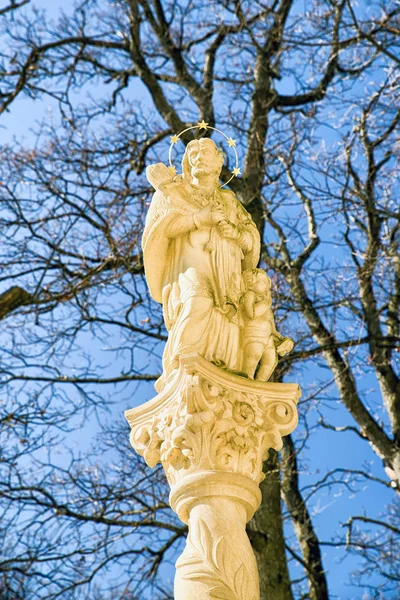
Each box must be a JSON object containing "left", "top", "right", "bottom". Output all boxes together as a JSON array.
[{"left": 142, "top": 177, "right": 260, "bottom": 390}]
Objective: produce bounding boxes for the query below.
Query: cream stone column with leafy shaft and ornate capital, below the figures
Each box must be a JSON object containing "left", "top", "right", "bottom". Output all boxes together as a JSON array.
[{"left": 125, "top": 354, "right": 300, "bottom": 600}]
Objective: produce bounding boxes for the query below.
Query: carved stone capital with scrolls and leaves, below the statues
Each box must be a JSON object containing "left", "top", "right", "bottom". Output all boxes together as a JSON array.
[{"left": 127, "top": 356, "right": 300, "bottom": 486}]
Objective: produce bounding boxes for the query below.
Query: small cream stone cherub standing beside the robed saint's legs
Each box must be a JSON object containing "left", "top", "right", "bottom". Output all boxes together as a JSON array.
[{"left": 240, "top": 269, "right": 293, "bottom": 381}]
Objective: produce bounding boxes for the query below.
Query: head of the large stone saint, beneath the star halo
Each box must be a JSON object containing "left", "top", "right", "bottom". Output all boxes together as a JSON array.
[{"left": 182, "top": 138, "right": 224, "bottom": 181}]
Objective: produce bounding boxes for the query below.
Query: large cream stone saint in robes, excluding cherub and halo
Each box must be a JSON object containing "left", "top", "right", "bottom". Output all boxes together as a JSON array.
[{"left": 142, "top": 138, "right": 290, "bottom": 391}]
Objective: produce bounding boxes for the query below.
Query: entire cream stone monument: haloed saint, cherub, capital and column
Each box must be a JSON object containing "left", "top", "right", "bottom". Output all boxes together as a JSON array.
[{"left": 125, "top": 126, "right": 300, "bottom": 600}]
